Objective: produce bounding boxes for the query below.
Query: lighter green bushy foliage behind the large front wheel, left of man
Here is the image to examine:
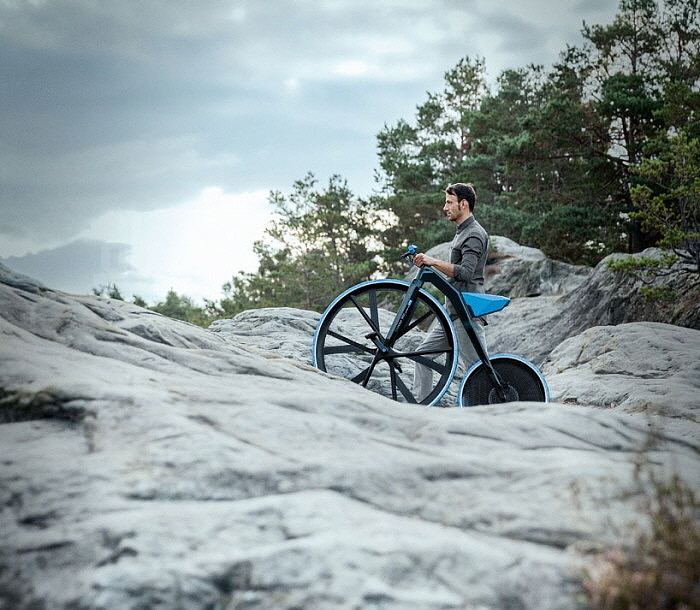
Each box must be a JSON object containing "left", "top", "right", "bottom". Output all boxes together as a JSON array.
[{"left": 219, "top": 174, "right": 379, "bottom": 316}]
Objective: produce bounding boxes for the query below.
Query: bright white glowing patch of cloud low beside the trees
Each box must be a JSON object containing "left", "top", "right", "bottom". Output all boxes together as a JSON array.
[{"left": 76, "top": 187, "right": 271, "bottom": 303}]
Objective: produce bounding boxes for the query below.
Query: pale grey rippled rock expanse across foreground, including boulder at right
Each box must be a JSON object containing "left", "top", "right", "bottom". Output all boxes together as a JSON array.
[{"left": 0, "top": 258, "right": 700, "bottom": 610}]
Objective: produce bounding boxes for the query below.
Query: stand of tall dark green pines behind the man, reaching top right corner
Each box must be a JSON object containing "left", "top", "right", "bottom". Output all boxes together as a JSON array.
[{"left": 378, "top": 0, "right": 700, "bottom": 264}]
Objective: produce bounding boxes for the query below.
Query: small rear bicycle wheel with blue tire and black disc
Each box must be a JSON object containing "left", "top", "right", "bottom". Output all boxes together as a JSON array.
[{"left": 459, "top": 354, "right": 549, "bottom": 407}]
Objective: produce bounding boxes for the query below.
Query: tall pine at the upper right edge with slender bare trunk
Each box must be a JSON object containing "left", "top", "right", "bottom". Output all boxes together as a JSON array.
[{"left": 583, "top": 0, "right": 700, "bottom": 252}]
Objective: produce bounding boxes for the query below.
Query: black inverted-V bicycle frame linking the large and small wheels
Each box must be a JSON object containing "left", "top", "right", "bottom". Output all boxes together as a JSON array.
[{"left": 385, "top": 266, "right": 507, "bottom": 401}]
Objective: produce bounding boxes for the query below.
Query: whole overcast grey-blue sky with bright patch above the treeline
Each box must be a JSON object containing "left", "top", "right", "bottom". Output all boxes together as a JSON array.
[{"left": 0, "top": 0, "right": 618, "bottom": 303}]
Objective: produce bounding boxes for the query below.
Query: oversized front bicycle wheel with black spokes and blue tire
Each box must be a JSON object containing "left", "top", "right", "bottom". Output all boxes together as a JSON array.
[{"left": 312, "top": 280, "right": 459, "bottom": 405}]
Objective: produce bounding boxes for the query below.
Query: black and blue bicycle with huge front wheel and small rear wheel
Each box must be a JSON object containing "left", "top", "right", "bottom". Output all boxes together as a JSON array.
[{"left": 312, "top": 245, "right": 549, "bottom": 407}]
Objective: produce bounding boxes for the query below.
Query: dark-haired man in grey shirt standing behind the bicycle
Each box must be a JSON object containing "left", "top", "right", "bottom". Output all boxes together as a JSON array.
[{"left": 413, "top": 182, "right": 489, "bottom": 402}]
